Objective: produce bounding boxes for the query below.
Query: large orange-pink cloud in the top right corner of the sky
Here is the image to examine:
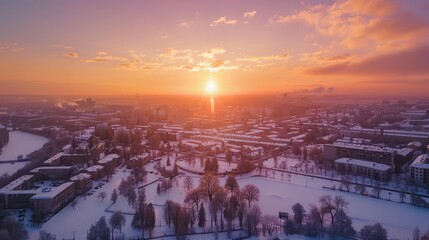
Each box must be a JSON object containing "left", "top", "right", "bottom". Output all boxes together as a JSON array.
[{"left": 269, "top": 0, "right": 429, "bottom": 48}]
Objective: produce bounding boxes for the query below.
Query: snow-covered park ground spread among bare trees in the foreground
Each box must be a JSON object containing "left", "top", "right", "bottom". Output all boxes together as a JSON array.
[{"left": 21, "top": 158, "right": 429, "bottom": 239}]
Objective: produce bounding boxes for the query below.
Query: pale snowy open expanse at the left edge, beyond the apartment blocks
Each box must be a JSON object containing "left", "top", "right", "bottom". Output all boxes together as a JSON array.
[{"left": 0, "top": 131, "right": 48, "bottom": 175}]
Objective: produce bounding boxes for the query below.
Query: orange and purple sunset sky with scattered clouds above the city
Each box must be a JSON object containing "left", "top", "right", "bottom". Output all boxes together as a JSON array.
[{"left": 0, "top": 0, "right": 429, "bottom": 96}]
